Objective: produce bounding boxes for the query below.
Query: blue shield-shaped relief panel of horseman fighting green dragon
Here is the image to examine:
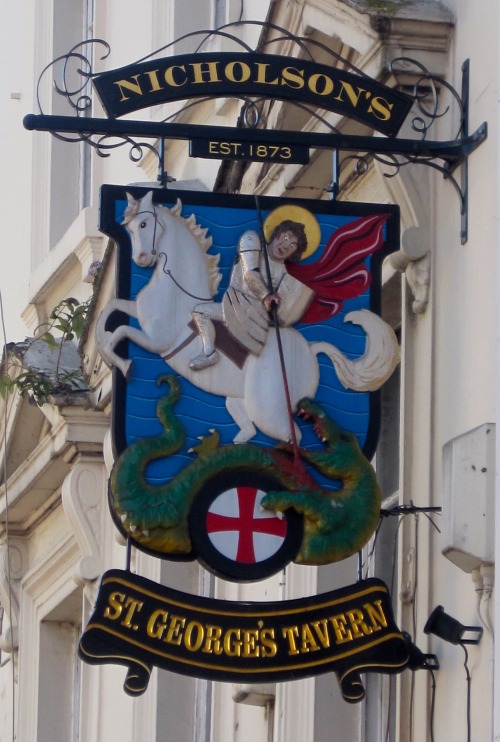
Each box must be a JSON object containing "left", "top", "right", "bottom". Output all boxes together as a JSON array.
[{"left": 96, "top": 186, "right": 399, "bottom": 581}]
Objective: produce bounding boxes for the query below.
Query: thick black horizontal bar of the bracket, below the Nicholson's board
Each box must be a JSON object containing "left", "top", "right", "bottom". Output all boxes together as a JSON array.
[{"left": 23, "top": 113, "right": 488, "bottom": 167}]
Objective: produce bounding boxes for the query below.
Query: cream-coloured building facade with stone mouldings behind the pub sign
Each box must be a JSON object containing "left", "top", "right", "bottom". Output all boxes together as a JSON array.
[{"left": 0, "top": 0, "right": 500, "bottom": 742}]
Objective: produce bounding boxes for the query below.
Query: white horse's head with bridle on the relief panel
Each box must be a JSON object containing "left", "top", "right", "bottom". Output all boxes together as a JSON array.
[{"left": 123, "top": 191, "right": 164, "bottom": 268}]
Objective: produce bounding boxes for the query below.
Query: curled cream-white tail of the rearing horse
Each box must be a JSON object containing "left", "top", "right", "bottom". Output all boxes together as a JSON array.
[{"left": 311, "top": 309, "right": 400, "bottom": 392}]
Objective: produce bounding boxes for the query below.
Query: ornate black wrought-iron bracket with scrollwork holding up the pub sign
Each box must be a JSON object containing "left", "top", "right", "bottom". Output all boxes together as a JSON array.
[{"left": 24, "top": 21, "right": 487, "bottom": 244}]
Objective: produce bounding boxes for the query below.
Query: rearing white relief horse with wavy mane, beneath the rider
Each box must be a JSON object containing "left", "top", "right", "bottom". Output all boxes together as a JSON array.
[{"left": 96, "top": 192, "right": 399, "bottom": 443}]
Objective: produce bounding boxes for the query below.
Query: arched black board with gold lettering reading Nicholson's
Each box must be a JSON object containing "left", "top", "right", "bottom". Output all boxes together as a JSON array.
[{"left": 93, "top": 52, "right": 413, "bottom": 136}]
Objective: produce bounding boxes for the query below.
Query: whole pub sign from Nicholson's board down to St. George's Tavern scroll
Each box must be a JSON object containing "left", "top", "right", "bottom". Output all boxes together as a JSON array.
[{"left": 72, "top": 39, "right": 411, "bottom": 702}]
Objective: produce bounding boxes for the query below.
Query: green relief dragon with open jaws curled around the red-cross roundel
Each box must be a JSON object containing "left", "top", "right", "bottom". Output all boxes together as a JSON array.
[{"left": 110, "top": 375, "right": 381, "bottom": 565}]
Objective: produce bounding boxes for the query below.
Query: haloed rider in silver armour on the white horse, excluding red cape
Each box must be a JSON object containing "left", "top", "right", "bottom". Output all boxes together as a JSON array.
[{"left": 189, "top": 220, "right": 314, "bottom": 371}]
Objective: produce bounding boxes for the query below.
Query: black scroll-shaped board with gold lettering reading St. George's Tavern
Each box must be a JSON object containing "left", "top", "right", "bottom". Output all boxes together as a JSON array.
[{"left": 80, "top": 570, "right": 408, "bottom": 702}]
